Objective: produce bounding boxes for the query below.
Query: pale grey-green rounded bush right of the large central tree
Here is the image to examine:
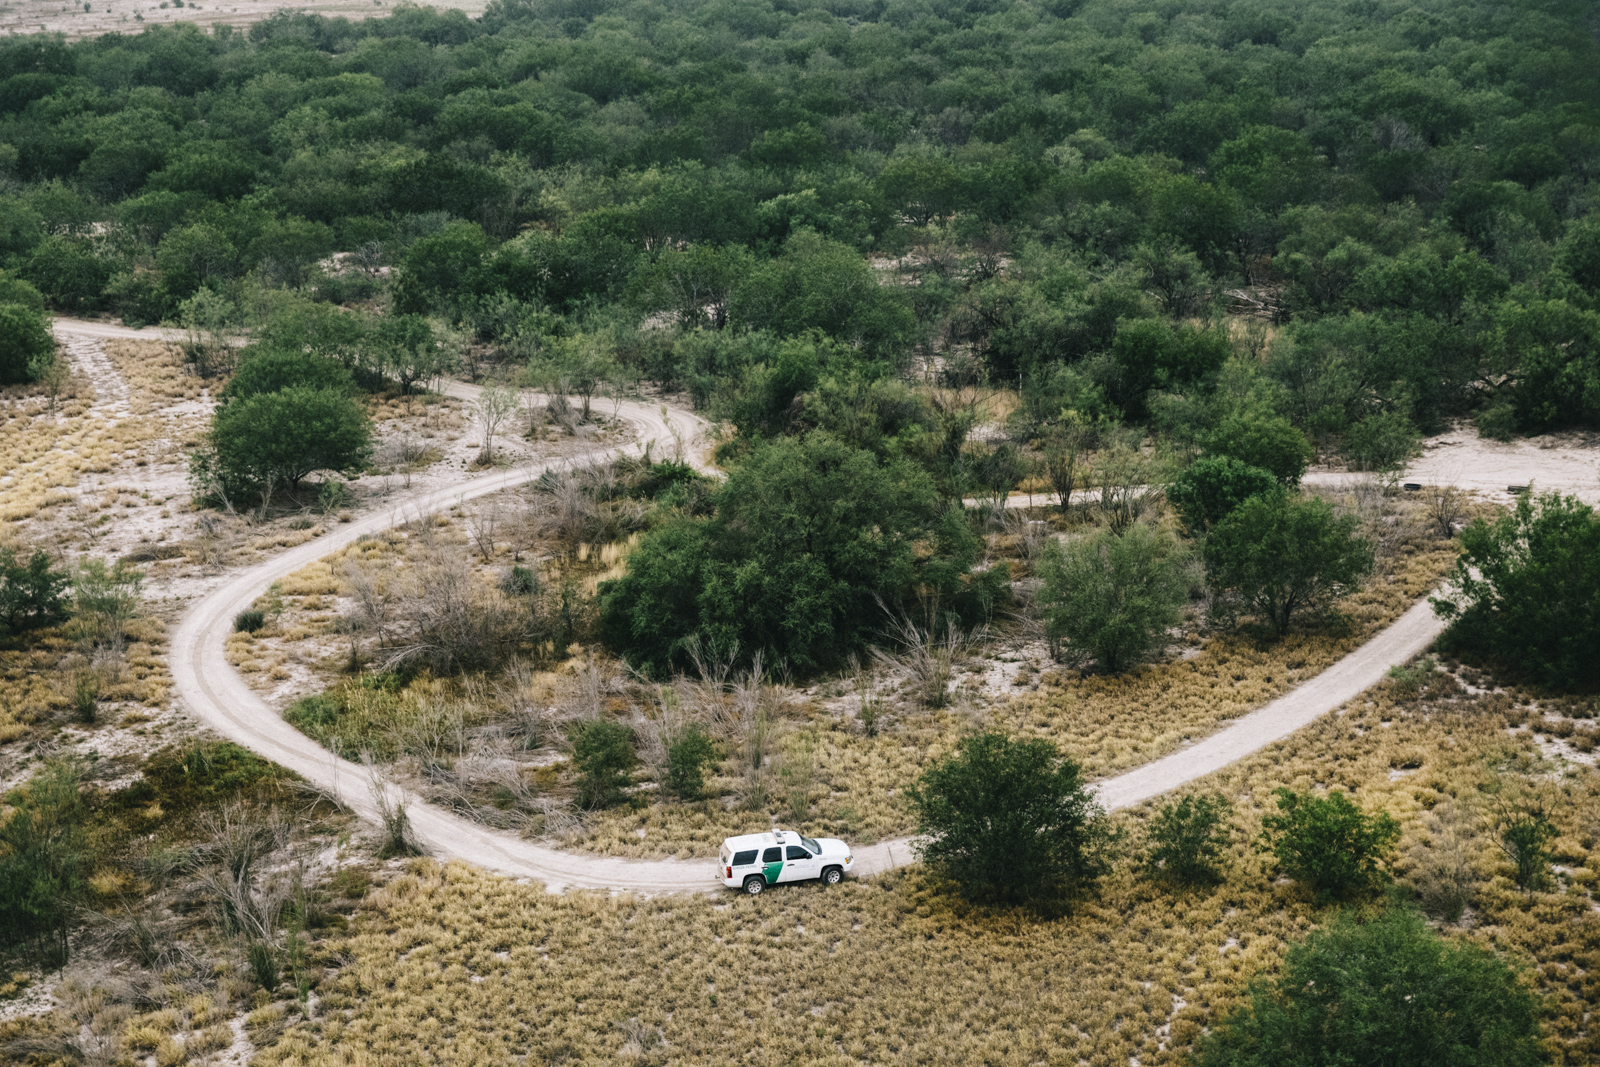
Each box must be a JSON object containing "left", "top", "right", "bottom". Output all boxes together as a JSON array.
[{"left": 1037, "top": 523, "right": 1190, "bottom": 673}]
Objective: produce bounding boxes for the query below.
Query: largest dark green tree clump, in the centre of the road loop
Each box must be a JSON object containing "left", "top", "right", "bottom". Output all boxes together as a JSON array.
[{"left": 600, "top": 432, "right": 1005, "bottom": 673}]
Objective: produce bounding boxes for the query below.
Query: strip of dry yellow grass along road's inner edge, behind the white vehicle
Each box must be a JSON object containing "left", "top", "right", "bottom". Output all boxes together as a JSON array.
[{"left": 570, "top": 542, "right": 1454, "bottom": 857}]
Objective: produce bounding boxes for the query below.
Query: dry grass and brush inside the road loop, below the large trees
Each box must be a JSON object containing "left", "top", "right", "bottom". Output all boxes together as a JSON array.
[{"left": 229, "top": 476, "right": 1454, "bottom": 856}]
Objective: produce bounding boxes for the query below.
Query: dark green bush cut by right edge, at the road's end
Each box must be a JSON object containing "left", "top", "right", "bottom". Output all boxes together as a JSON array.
[{"left": 1432, "top": 493, "right": 1600, "bottom": 691}]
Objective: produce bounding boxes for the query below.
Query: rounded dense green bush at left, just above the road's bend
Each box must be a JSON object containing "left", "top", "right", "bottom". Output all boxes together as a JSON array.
[{"left": 211, "top": 386, "right": 371, "bottom": 491}]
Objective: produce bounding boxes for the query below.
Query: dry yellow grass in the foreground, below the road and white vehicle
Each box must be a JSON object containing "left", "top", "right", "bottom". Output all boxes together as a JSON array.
[{"left": 258, "top": 671, "right": 1600, "bottom": 1067}]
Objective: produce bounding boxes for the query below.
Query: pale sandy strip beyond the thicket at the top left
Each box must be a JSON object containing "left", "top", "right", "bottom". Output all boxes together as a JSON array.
[{"left": 0, "top": 0, "right": 488, "bottom": 40}]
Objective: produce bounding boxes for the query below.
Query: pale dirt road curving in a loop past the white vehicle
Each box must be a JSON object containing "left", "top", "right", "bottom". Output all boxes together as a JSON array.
[{"left": 43, "top": 320, "right": 1523, "bottom": 893}]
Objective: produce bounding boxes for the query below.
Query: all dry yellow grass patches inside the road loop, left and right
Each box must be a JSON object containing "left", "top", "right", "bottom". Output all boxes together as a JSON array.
[{"left": 256, "top": 483, "right": 1454, "bottom": 857}]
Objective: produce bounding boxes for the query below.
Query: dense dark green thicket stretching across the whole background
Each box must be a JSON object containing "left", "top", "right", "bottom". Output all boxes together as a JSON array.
[{"left": 0, "top": 0, "right": 1600, "bottom": 438}]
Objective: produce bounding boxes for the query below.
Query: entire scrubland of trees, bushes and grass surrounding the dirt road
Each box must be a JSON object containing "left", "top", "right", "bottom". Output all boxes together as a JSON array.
[{"left": 0, "top": 0, "right": 1600, "bottom": 1067}]
